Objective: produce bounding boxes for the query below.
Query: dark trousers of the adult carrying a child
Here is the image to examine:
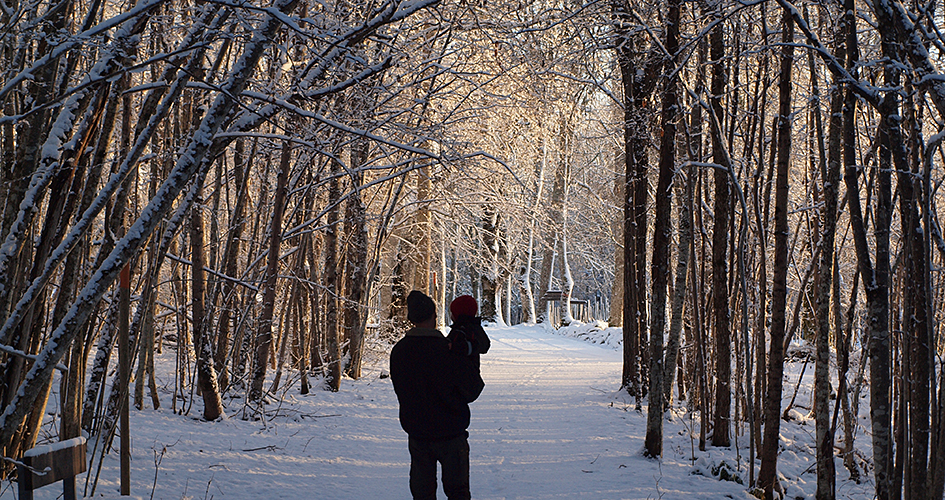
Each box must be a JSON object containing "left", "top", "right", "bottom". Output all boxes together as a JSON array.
[{"left": 408, "top": 434, "right": 470, "bottom": 500}]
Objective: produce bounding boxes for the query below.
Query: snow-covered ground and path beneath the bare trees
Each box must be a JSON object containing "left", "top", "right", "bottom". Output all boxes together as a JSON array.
[{"left": 7, "top": 325, "right": 872, "bottom": 500}]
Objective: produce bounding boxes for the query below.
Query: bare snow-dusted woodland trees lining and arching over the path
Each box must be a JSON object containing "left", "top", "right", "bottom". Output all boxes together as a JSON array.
[{"left": 0, "top": 0, "right": 945, "bottom": 499}]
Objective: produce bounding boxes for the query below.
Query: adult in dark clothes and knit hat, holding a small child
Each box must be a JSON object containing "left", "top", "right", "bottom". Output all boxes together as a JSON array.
[{"left": 390, "top": 290, "right": 485, "bottom": 500}]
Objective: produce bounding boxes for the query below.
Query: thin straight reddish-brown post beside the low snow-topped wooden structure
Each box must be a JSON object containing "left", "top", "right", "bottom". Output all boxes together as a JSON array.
[{"left": 118, "top": 264, "right": 131, "bottom": 496}]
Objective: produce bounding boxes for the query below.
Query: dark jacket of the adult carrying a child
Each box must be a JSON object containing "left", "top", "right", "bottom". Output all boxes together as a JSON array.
[{"left": 390, "top": 327, "right": 485, "bottom": 441}]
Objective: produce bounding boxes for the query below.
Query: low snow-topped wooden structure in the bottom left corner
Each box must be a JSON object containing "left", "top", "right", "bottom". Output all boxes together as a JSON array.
[{"left": 16, "top": 437, "right": 86, "bottom": 500}]
